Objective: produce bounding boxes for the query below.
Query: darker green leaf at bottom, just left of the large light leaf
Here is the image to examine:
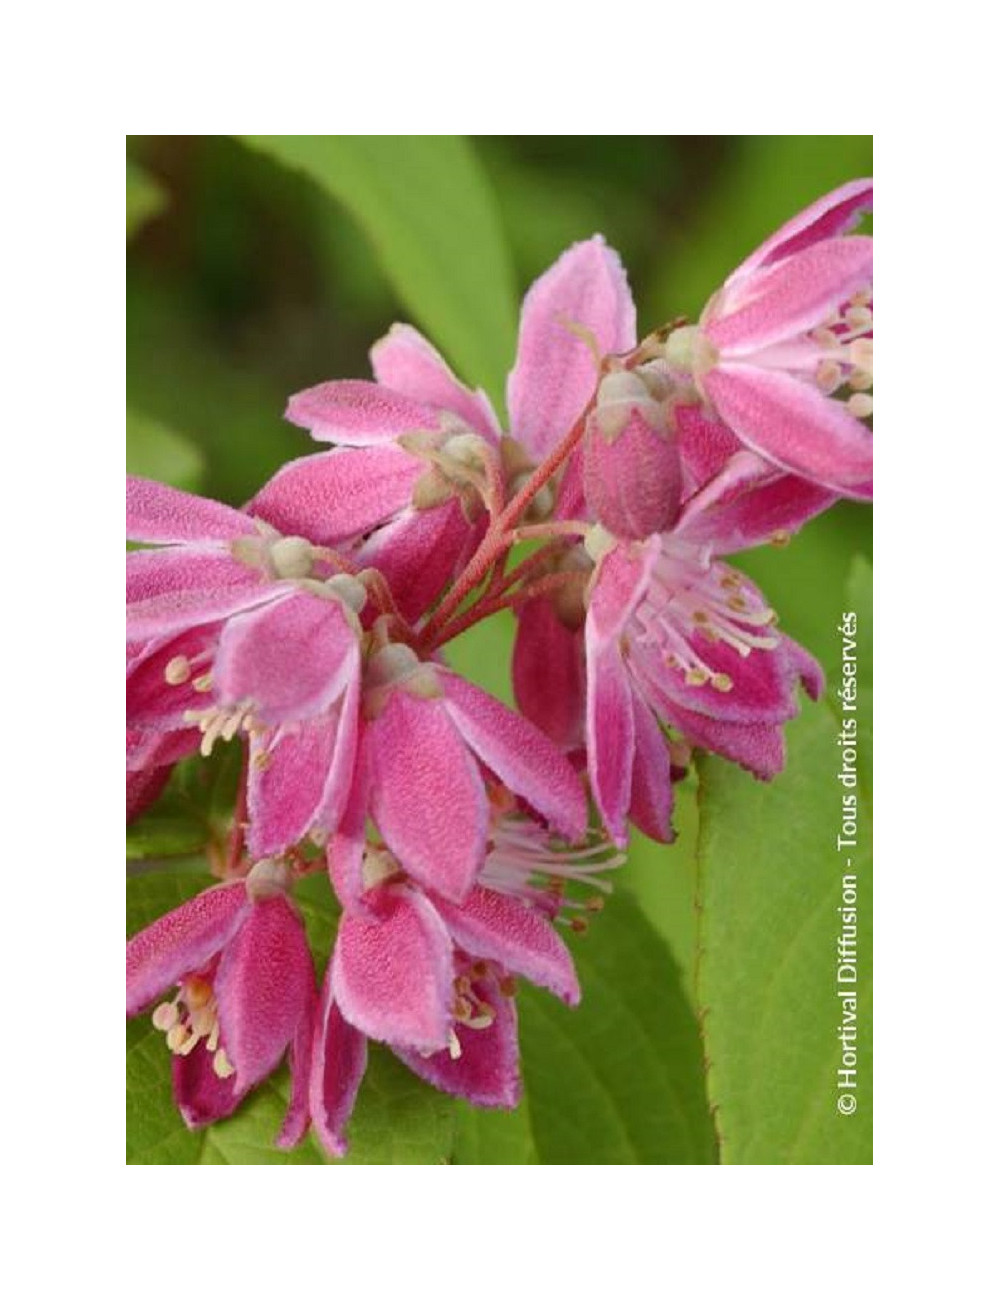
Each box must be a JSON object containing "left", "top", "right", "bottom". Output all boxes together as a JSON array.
[{"left": 518, "top": 891, "right": 715, "bottom": 1165}]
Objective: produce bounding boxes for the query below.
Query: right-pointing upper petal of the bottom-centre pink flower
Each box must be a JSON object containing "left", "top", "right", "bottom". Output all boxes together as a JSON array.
[{"left": 437, "top": 885, "right": 580, "bottom": 1006}]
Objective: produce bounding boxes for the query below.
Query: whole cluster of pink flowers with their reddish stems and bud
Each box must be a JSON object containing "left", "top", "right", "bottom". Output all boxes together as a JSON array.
[{"left": 126, "top": 182, "right": 873, "bottom": 1154}]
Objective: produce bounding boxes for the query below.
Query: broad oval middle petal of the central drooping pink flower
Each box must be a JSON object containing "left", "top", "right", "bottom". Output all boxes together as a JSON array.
[{"left": 362, "top": 689, "right": 486, "bottom": 902}]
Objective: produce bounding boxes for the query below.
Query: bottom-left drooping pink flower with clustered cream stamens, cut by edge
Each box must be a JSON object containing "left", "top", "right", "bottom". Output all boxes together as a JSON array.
[{"left": 126, "top": 862, "right": 316, "bottom": 1147}]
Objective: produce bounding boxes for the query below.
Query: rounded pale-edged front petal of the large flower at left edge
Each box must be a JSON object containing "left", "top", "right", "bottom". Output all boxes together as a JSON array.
[{"left": 212, "top": 592, "right": 360, "bottom": 727}]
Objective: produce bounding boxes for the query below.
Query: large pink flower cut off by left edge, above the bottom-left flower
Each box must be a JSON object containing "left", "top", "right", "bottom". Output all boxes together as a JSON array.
[{"left": 126, "top": 478, "right": 367, "bottom": 857}]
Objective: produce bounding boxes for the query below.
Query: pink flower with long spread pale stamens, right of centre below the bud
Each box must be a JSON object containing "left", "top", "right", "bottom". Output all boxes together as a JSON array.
[{"left": 585, "top": 512, "right": 823, "bottom": 845}]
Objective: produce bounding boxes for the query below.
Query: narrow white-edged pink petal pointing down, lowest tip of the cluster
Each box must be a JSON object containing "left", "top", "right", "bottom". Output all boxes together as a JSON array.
[{"left": 309, "top": 963, "right": 368, "bottom": 1156}]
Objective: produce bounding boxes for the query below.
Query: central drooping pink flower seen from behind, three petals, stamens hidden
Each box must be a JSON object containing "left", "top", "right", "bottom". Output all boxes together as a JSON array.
[{"left": 329, "top": 644, "right": 586, "bottom": 902}]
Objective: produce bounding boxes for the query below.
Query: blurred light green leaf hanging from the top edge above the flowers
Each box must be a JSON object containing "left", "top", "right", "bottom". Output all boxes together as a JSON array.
[{"left": 236, "top": 135, "right": 516, "bottom": 400}]
